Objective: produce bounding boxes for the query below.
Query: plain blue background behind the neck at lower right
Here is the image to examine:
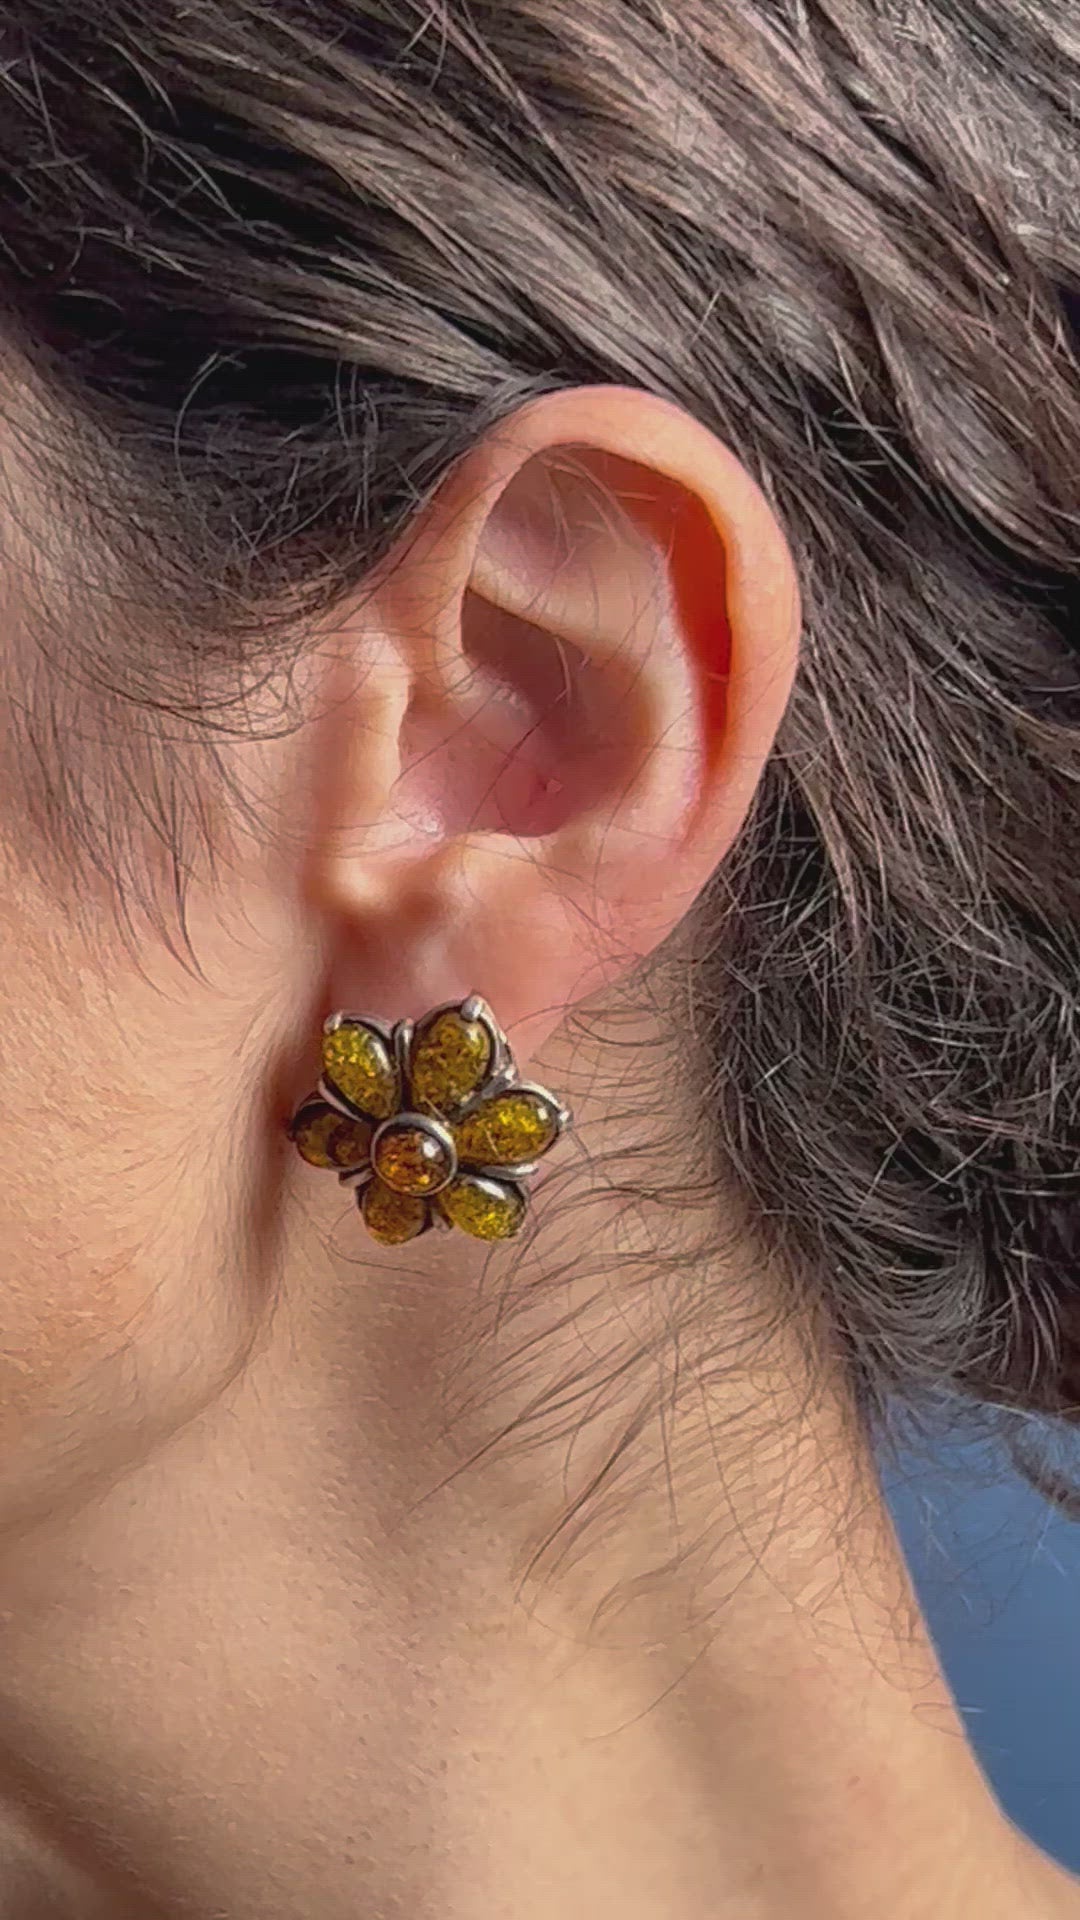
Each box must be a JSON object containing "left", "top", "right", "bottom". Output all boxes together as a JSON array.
[{"left": 886, "top": 1434, "right": 1080, "bottom": 1872}]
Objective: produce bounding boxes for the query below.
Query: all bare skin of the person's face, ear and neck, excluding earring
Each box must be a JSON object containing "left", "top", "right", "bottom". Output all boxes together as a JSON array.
[{"left": 0, "top": 388, "right": 1080, "bottom": 1920}]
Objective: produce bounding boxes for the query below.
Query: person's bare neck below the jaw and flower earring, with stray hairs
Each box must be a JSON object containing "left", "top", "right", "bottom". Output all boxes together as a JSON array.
[{"left": 0, "top": 1205, "right": 1080, "bottom": 1920}]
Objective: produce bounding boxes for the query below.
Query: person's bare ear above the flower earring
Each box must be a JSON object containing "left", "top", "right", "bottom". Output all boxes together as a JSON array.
[{"left": 304, "top": 388, "right": 799, "bottom": 1056}]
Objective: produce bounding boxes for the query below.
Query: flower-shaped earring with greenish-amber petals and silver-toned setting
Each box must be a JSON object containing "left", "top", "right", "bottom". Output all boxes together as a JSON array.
[{"left": 288, "top": 995, "right": 571, "bottom": 1246}]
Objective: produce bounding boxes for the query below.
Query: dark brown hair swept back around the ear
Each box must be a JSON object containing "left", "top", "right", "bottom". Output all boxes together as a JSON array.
[{"left": 0, "top": 0, "right": 1080, "bottom": 1489}]
